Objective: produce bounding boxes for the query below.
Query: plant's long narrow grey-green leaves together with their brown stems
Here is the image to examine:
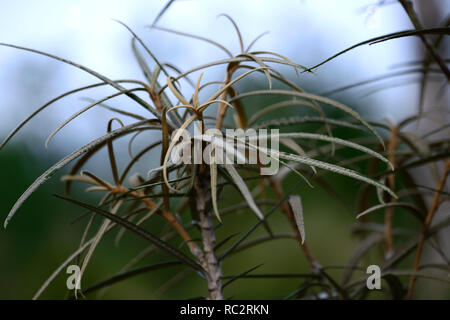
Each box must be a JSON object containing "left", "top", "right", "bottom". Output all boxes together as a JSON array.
[{"left": 0, "top": 1, "right": 450, "bottom": 299}]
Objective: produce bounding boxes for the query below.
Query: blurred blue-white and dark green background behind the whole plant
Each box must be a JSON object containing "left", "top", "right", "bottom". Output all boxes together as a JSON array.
[{"left": 0, "top": 0, "right": 450, "bottom": 299}]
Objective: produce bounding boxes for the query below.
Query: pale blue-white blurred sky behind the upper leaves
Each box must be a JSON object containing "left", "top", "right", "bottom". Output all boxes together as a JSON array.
[{"left": 0, "top": 0, "right": 450, "bottom": 159}]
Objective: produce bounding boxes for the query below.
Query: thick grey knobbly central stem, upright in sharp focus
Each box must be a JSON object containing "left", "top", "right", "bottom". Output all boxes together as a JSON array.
[{"left": 195, "top": 175, "right": 223, "bottom": 300}]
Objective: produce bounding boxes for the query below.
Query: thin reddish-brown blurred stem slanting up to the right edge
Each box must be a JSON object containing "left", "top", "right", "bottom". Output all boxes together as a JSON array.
[{"left": 406, "top": 160, "right": 450, "bottom": 299}]
